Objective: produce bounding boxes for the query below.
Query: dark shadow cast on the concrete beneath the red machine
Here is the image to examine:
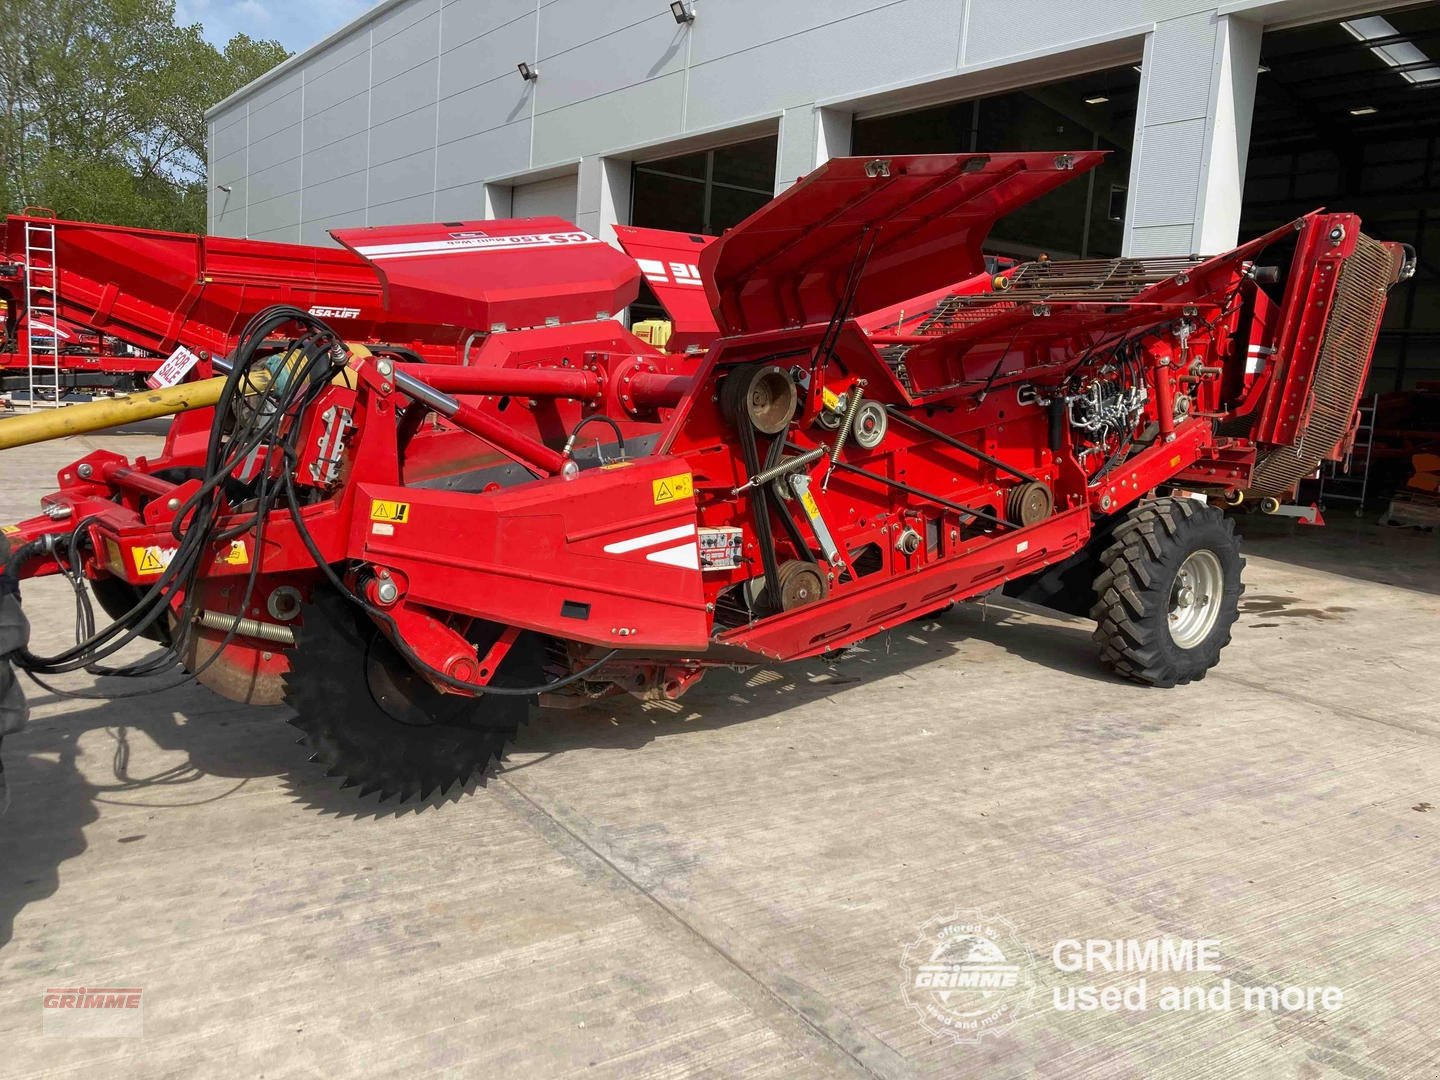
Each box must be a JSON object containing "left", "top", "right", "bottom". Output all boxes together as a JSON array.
[{"left": 0, "top": 599, "right": 1112, "bottom": 948}]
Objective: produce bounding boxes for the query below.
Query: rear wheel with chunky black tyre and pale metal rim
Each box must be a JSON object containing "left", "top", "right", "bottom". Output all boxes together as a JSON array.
[{"left": 1090, "top": 498, "right": 1246, "bottom": 687}]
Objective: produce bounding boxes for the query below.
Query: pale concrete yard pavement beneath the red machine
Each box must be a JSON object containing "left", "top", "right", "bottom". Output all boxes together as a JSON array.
[{"left": 0, "top": 433, "right": 1440, "bottom": 1080}]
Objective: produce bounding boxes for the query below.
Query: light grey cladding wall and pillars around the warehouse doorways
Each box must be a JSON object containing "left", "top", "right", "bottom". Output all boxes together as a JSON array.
[{"left": 207, "top": 0, "right": 1319, "bottom": 246}]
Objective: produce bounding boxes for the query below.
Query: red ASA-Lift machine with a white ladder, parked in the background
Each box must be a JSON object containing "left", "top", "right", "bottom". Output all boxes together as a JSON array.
[{"left": 0, "top": 212, "right": 593, "bottom": 392}]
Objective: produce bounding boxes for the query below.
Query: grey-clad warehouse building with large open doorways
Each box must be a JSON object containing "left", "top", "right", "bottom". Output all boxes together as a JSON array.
[{"left": 207, "top": 0, "right": 1440, "bottom": 389}]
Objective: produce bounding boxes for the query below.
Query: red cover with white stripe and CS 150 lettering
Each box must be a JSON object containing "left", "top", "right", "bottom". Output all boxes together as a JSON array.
[{"left": 330, "top": 217, "right": 639, "bottom": 330}]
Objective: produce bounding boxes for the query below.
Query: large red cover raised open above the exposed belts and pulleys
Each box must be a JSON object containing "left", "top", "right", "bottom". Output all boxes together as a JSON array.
[{"left": 700, "top": 150, "right": 1104, "bottom": 334}]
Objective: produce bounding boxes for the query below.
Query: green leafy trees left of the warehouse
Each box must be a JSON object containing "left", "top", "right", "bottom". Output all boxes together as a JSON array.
[{"left": 0, "top": 0, "right": 288, "bottom": 232}]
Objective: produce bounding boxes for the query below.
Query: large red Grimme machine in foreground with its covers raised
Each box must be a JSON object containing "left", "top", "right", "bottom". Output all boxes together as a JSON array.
[{"left": 0, "top": 153, "right": 1410, "bottom": 798}]
